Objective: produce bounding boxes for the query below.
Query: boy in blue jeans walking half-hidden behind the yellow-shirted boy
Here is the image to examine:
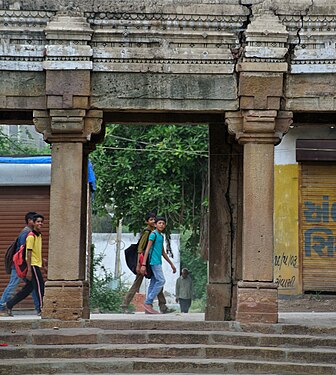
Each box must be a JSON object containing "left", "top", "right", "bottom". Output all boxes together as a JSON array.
[{"left": 0, "top": 211, "right": 40, "bottom": 315}]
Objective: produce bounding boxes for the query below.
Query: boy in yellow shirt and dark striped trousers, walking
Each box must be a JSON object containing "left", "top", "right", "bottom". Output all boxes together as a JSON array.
[{"left": 3, "top": 214, "right": 44, "bottom": 316}]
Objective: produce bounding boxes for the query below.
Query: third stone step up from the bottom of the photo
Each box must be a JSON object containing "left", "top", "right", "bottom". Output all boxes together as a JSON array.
[{"left": 0, "top": 328, "right": 336, "bottom": 348}]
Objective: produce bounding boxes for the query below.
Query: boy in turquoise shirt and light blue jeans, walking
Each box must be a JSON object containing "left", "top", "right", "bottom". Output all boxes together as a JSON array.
[{"left": 140, "top": 216, "right": 176, "bottom": 314}]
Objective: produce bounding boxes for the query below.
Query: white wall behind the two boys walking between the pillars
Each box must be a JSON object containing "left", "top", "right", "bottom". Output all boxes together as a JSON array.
[{"left": 92, "top": 233, "right": 180, "bottom": 304}]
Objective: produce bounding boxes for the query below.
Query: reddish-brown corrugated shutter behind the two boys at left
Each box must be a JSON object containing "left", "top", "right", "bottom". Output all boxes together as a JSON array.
[{"left": 0, "top": 186, "right": 50, "bottom": 309}]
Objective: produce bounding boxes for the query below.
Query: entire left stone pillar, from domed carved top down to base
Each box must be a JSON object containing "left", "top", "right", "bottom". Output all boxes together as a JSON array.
[{"left": 34, "top": 15, "right": 103, "bottom": 320}]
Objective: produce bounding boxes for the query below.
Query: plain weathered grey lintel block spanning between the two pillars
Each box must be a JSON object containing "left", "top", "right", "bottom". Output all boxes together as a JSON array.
[{"left": 91, "top": 72, "right": 238, "bottom": 111}]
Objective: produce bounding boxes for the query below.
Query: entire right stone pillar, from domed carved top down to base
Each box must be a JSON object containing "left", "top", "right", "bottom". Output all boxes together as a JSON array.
[{"left": 226, "top": 9, "right": 292, "bottom": 323}]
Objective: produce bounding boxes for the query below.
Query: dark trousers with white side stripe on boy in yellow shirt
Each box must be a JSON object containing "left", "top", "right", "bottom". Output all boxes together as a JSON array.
[{"left": 7, "top": 266, "right": 44, "bottom": 310}]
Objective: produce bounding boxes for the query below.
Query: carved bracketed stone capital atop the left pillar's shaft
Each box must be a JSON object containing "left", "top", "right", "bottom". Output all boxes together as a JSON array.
[{"left": 34, "top": 109, "right": 103, "bottom": 143}]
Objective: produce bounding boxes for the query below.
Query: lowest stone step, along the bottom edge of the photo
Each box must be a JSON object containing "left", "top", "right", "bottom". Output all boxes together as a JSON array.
[{"left": 0, "top": 358, "right": 336, "bottom": 375}]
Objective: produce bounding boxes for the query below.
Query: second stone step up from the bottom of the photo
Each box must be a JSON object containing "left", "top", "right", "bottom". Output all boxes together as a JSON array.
[{"left": 0, "top": 344, "right": 336, "bottom": 364}]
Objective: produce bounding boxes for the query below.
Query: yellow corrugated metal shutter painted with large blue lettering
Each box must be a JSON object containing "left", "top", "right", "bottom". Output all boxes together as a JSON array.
[{"left": 300, "top": 163, "right": 336, "bottom": 292}]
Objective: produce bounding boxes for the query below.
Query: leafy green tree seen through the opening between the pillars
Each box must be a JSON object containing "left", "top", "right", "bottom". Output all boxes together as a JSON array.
[{"left": 90, "top": 124, "right": 208, "bottom": 251}]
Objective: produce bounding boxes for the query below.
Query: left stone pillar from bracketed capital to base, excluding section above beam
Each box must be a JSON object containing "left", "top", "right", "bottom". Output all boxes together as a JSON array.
[{"left": 34, "top": 110, "right": 102, "bottom": 320}]
